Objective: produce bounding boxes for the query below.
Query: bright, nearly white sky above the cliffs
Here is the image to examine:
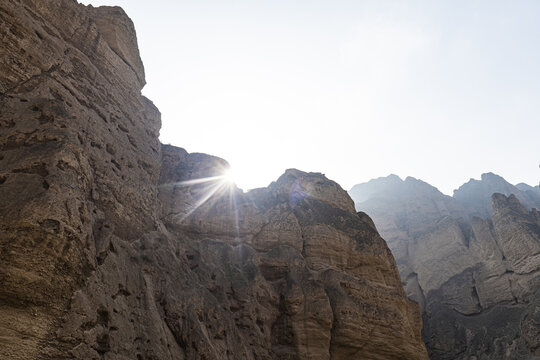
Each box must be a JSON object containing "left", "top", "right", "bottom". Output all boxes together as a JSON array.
[{"left": 78, "top": 0, "right": 540, "bottom": 194}]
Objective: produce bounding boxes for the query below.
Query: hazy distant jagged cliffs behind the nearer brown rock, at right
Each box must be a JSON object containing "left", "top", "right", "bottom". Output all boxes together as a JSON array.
[{"left": 350, "top": 174, "right": 540, "bottom": 360}]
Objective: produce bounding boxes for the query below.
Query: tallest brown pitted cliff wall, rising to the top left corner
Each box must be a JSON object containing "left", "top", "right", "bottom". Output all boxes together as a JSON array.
[{"left": 0, "top": 0, "right": 161, "bottom": 359}]
